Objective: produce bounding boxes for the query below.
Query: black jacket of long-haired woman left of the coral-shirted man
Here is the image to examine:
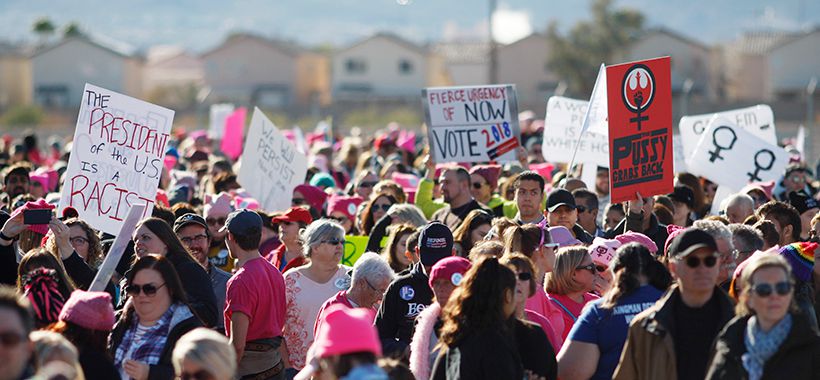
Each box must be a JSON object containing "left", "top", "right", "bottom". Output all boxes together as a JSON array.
[{"left": 166, "top": 255, "right": 221, "bottom": 327}]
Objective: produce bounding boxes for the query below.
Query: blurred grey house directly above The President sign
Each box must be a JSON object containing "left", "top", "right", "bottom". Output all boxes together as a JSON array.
[{"left": 31, "top": 36, "right": 143, "bottom": 108}]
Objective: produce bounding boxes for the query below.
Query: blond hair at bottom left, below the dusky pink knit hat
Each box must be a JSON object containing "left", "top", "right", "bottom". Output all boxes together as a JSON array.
[{"left": 29, "top": 330, "right": 85, "bottom": 380}]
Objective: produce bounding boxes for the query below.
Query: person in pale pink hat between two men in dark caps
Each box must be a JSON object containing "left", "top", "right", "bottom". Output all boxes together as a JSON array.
[{"left": 202, "top": 192, "right": 234, "bottom": 273}]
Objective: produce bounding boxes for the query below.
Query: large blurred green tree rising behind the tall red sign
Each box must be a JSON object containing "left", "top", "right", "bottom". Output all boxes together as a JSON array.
[{"left": 547, "top": 0, "right": 644, "bottom": 98}]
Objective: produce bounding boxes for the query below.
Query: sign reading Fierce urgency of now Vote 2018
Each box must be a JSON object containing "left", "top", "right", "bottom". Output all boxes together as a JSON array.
[{"left": 421, "top": 85, "right": 521, "bottom": 163}]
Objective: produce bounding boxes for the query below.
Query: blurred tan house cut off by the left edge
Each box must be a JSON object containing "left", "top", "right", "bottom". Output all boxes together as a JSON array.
[{"left": 0, "top": 43, "right": 32, "bottom": 111}]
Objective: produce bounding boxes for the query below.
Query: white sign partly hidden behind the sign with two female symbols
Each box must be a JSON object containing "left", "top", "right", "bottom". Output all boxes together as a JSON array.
[{"left": 678, "top": 104, "right": 777, "bottom": 161}]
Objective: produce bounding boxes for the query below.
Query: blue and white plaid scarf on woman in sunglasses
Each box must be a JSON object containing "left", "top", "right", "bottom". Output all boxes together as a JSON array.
[{"left": 114, "top": 304, "right": 184, "bottom": 368}]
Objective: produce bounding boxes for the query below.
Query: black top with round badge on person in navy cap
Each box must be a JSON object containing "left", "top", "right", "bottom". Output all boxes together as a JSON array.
[{"left": 376, "top": 263, "right": 433, "bottom": 356}]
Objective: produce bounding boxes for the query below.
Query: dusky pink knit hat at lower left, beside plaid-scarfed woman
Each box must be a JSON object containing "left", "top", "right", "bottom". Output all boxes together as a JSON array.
[{"left": 60, "top": 289, "right": 114, "bottom": 331}]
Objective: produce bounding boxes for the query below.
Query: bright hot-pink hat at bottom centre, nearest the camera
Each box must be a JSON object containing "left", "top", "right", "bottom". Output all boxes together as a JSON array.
[{"left": 311, "top": 305, "right": 382, "bottom": 358}]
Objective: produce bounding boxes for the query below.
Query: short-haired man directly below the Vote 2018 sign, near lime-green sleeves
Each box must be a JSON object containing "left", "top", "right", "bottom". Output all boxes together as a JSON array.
[{"left": 431, "top": 166, "right": 492, "bottom": 231}]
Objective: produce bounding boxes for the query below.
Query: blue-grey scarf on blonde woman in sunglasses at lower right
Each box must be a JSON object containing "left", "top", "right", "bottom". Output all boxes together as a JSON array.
[{"left": 741, "top": 313, "right": 792, "bottom": 380}]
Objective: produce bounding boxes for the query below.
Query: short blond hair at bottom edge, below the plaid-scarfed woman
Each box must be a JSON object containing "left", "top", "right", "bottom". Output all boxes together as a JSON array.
[{"left": 171, "top": 327, "right": 236, "bottom": 380}]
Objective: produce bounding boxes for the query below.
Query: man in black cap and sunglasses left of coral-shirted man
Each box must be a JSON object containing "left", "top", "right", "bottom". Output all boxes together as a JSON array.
[{"left": 174, "top": 213, "right": 231, "bottom": 332}]
